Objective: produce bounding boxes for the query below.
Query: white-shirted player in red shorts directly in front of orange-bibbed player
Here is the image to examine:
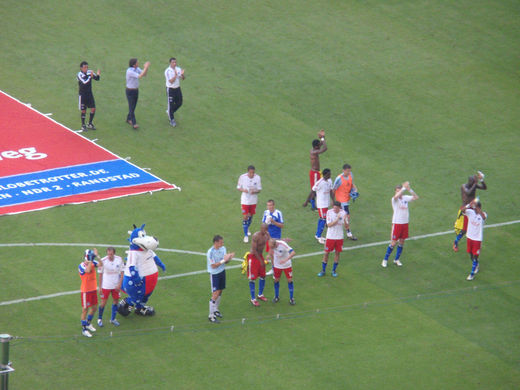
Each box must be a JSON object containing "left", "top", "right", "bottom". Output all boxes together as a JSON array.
[{"left": 318, "top": 201, "right": 348, "bottom": 277}]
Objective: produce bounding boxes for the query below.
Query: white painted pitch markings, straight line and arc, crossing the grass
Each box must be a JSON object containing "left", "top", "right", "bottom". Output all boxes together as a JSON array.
[{"left": 0, "top": 219, "right": 520, "bottom": 306}]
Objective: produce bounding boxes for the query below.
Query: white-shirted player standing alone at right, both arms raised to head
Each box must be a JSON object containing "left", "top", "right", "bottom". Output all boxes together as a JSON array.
[{"left": 381, "top": 181, "right": 419, "bottom": 268}]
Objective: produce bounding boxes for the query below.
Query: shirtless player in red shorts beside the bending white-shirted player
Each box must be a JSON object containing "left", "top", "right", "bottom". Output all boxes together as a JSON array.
[{"left": 247, "top": 223, "right": 270, "bottom": 306}]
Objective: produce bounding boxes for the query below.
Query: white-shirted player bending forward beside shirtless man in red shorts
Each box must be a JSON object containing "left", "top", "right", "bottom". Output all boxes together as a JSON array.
[{"left": 269, "top": 238, "right": 296, "bottom": 305}]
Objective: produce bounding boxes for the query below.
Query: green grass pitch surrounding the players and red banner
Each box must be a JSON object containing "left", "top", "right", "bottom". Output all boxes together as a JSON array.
[{"left": 0, "top": 0, "right": 520, "bottom": 390}]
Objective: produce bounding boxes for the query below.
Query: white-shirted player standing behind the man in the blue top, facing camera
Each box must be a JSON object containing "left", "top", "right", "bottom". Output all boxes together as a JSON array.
[{"left": 237, "top": 165, "right": 262, "bottom": 242}]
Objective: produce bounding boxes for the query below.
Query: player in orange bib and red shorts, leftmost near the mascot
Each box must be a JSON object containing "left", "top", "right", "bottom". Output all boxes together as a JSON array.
[{"left": 78, "top": 248, "right": 99, "bottom": 337}]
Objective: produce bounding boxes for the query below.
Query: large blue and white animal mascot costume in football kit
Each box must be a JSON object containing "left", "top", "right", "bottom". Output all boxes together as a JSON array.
[{"left": 117, "top": 224, "right": 166, "bottom": 317}]
